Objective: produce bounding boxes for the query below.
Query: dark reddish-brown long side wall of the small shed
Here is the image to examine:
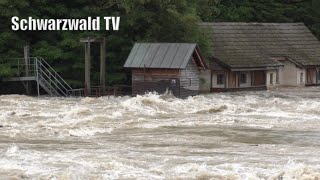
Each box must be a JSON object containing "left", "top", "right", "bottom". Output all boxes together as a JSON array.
[{"left": 132, "top": 69, "right": 180, "bottom": 96}]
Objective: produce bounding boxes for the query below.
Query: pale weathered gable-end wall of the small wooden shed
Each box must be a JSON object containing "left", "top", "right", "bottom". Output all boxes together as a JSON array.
[{"left": 179, "top": 59, "right": 200, "bottom": 98}]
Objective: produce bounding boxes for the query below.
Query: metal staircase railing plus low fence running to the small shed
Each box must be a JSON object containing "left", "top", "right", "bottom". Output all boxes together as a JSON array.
[{"left": 6, "top": 57, "right": 132, "bottom": 97}]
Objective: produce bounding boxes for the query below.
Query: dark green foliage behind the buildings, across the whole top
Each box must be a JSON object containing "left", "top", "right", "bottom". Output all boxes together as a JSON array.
[{"left": 0, "top": 0, "right": 320, "bottom": 87}]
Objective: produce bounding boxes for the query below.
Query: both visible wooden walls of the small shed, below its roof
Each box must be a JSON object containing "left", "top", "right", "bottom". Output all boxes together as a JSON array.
[{"left": 132, "top": 60, "right": 200, "bottom": 98}]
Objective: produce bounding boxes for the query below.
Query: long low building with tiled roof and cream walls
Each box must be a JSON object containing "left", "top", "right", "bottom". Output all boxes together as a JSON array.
[{"left": 201, "top": 22, "right": 320, "bottom": 92}]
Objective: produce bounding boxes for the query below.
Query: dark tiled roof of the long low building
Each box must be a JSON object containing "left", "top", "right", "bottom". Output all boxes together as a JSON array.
[{"left": 200, "top": 23, "right": 320, "bottom": 67}]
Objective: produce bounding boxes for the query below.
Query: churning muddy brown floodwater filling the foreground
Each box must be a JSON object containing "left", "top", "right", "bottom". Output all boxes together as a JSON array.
[{"left": 0, "top": 88, "right": 320, "bottom": 180}]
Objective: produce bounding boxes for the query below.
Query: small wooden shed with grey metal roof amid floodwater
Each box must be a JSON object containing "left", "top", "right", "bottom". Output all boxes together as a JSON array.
[{"left": 124, "top": 43, "right": 206, "bottom": 98}]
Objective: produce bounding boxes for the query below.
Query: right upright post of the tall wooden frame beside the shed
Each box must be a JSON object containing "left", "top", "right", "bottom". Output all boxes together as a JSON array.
[{"left": 100, "top": 38, "right": 106, "bottom": 94}]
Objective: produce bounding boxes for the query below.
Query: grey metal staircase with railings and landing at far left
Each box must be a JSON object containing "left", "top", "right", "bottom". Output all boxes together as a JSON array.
[{"left": 5, "top": 57, "right": 72, "bottom": 97}]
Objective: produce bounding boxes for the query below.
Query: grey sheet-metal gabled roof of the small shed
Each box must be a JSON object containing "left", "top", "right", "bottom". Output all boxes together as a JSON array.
[{"left": 124, "top": 43, "right": 205, "bottom": 69}]
